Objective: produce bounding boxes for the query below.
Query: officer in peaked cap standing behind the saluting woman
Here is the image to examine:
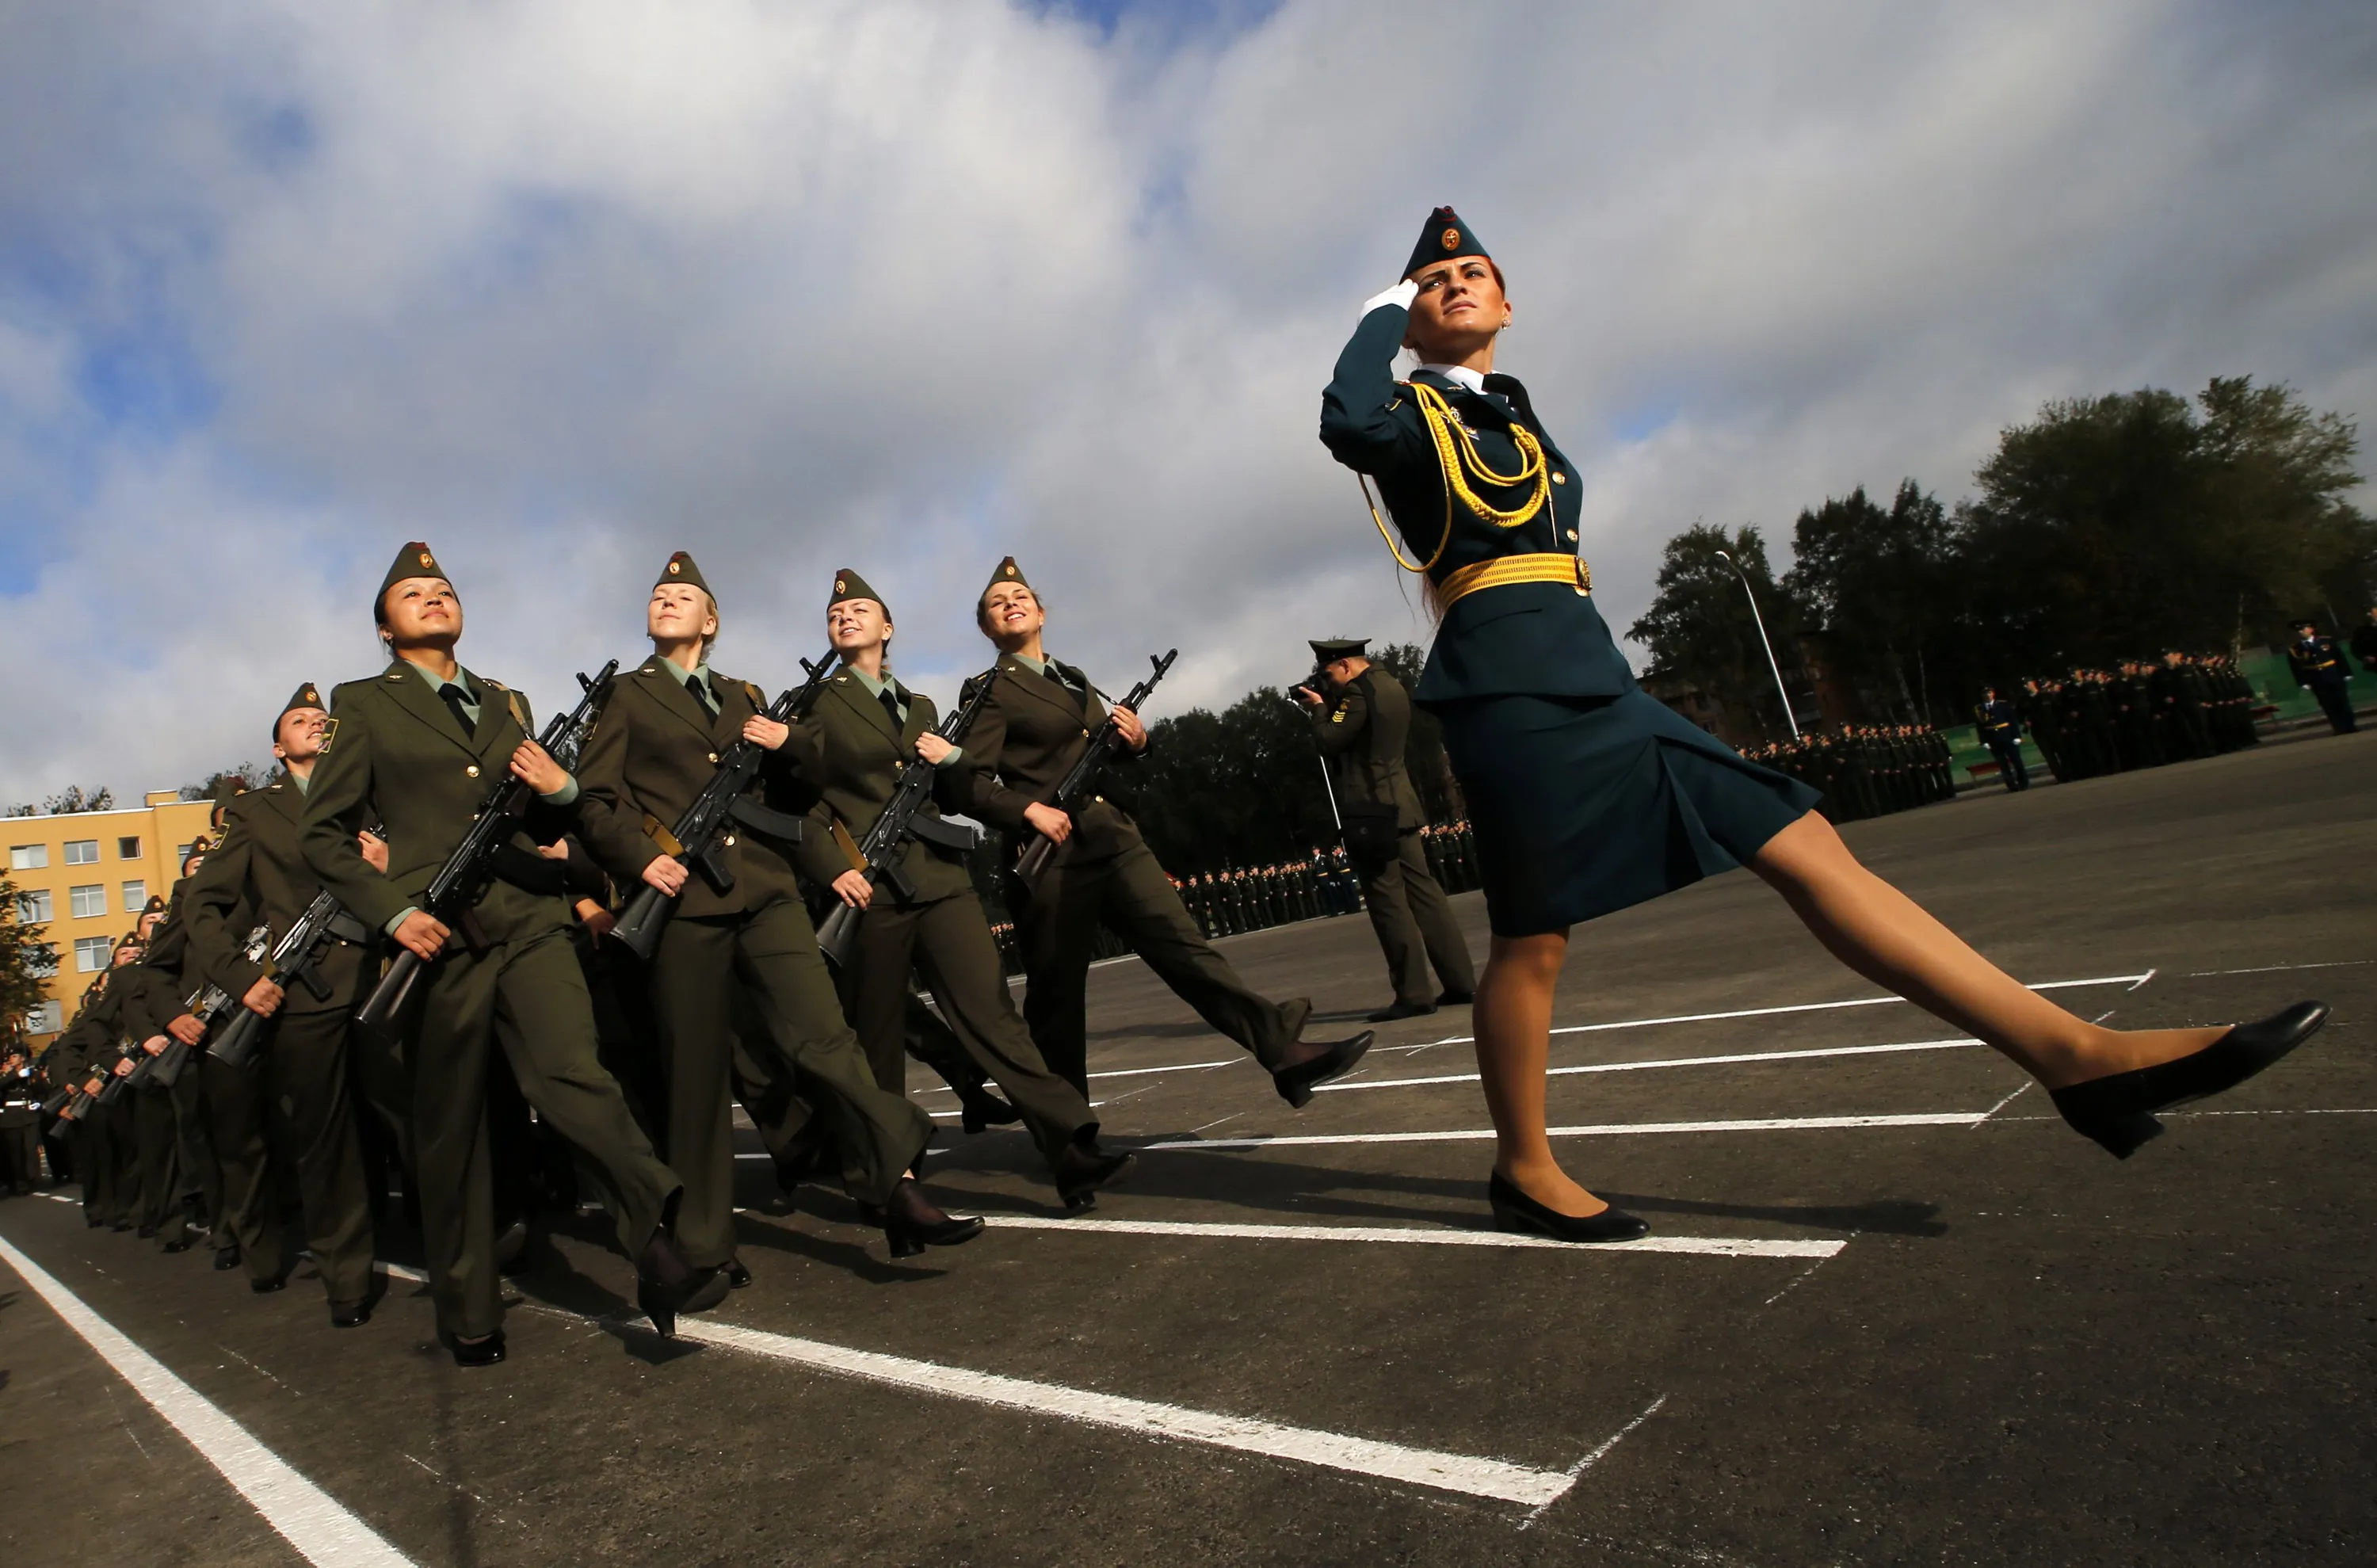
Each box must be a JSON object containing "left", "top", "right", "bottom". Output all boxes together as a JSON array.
[{"left": 1291, "top": 637, "right": 1478, "bottom": 1024}]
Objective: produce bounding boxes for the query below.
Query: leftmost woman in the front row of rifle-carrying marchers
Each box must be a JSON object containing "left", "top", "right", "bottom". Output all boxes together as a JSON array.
[{"left": 297, "top": 542, "right": 725, "bottom": 1366}]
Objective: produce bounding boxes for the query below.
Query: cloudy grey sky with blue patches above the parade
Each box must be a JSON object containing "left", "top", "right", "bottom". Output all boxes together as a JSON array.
[{"left": 0, "top": 0, "right": 2377, "bottom": 800}]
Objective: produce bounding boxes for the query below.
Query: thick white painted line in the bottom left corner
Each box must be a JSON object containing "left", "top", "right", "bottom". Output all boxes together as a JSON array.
[{"left": 0, "top": 1240, "right": 414, "bottom": 1568}]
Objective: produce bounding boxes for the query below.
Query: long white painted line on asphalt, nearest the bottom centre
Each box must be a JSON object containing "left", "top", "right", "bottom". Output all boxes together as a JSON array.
[{"left": 670, "top": 1318, "right": 1576, "bottom": 1509}]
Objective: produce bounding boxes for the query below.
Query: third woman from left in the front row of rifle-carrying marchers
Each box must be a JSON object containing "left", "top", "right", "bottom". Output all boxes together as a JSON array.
[{"left": 801, "top": 570, "right": 1134, "bottom": 1209}]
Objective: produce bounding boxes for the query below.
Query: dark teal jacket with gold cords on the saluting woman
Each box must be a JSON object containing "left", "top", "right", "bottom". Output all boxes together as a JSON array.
[{"left": 1322, "top": 304, "right": 1633, "bottom": 704}]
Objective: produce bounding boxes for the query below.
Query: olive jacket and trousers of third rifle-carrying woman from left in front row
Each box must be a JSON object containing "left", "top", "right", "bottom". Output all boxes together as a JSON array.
[{"left": 801, "top": 673, "right": 1098, "bottom": 1162}]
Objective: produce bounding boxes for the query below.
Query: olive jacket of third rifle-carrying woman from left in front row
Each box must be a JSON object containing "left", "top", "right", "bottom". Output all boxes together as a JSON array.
[{"left": 801, "top": 673, "right": 970, "bottom": 902}]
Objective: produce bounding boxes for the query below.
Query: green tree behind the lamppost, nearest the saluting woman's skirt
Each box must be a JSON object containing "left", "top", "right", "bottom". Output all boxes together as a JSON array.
[{"left": 1626, "top": 523, "right": 1802, "bottom": 739}]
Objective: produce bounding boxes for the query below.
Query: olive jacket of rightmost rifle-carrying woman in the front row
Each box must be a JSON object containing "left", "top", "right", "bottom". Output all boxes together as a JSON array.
[{"left": 965, "top": 654, "right": 1141, "bottom": 860}]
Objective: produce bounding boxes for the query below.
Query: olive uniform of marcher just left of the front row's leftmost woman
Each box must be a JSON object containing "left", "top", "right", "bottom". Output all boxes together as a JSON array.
[{"left": 185, "top": 775, "right": 371, "bottom": 1304}]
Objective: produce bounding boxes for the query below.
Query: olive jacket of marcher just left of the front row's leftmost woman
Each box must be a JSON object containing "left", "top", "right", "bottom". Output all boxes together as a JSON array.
[{"left": 183, "top": 769, "right": 366, "bottom": 1012}]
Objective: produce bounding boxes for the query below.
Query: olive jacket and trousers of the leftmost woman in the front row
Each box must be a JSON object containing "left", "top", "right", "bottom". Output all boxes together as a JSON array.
[{"left": 297, "top": 660, "right": 680, "bottom": 1340}]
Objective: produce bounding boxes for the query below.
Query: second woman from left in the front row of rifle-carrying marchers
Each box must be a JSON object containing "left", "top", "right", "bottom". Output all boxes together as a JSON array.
[{"left": 578, "top": 551, "right": 982, "bottom": 1266}]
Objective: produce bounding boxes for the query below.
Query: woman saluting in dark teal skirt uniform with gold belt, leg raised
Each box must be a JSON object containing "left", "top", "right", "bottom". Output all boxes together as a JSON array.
[{"left": 1322, "top": 207, "right": 2327, "bottom": 1240}]
